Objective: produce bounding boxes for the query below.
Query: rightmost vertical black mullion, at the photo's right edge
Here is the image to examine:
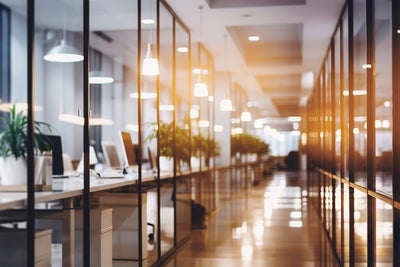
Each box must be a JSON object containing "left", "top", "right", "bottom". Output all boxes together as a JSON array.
[{"left": 392, "top": 1, "right": 400, "bottom": 266}]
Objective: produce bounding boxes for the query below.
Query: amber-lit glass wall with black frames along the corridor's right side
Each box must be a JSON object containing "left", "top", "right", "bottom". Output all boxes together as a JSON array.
[{"left": 307, "top": 0, "right": 399, "bottom": 266}]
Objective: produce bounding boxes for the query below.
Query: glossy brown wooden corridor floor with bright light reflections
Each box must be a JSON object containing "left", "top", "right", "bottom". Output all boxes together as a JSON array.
[{"left": 163, "top": 172, "right": 336, "bottom": 267}]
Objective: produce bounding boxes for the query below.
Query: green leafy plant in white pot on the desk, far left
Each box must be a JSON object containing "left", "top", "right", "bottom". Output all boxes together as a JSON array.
[{"left": 0, "top": 105, "right": 52, "bottom": 185}]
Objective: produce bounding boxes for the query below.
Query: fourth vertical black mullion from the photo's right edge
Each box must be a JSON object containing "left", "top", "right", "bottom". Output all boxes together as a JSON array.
[{"left": 340, "top": 19, "right": 346, "bottom": 266}]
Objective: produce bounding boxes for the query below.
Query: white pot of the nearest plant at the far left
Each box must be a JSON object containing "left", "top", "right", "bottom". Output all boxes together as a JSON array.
[{"left": 0, "top": 156, "right": 27, "bottom": 185}]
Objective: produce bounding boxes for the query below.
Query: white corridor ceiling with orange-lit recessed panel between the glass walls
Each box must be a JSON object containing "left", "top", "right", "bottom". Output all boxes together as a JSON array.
[{"left": 166, "top": 0, "right": 345, "bottom": 128}]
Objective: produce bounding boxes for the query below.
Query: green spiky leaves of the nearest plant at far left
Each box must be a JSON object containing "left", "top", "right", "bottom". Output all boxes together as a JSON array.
[{"left": 0, "top": 105, "right": 52, "bottom": 159}]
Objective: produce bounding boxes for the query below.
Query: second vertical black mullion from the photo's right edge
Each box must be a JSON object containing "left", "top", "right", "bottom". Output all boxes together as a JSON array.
[{"left": 366, "top": 0, "right": 376, "bottom": 267}]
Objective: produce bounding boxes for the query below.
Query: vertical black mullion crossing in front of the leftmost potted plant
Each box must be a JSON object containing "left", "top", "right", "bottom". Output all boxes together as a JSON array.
[{"left": 27, "top": 0, "right": 35, "bottom": 266}]
